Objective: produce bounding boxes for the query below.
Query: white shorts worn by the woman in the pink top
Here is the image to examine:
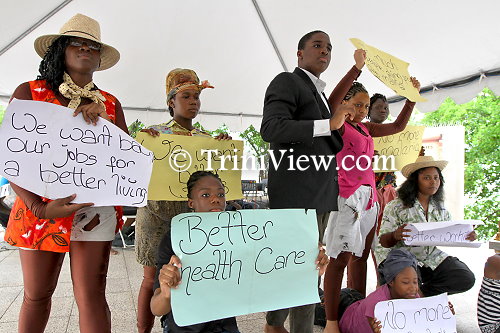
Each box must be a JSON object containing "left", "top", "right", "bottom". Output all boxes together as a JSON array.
[{"left": 323, "top": 185, "right": 378, "bottom": 258}]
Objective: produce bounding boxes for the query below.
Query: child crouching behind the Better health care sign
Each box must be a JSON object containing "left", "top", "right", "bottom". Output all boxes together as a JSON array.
[{"left": 151, "top": 171, "right": 239, "bottom": 333}]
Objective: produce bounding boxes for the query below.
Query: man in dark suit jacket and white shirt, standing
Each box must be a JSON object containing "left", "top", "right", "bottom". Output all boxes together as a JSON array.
[{"left": 260, "top": 31, "right": 354, "bottom": 333}]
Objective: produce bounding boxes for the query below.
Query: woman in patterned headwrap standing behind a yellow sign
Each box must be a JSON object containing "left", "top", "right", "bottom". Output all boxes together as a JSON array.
[{"left": 135, "top": 68, "right": 231, "bottom": 333}]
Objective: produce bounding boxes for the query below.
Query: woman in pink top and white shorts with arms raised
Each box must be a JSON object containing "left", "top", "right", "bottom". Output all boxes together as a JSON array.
[{"left": 324, "top": 50, "right": 420, "bottom": 333}]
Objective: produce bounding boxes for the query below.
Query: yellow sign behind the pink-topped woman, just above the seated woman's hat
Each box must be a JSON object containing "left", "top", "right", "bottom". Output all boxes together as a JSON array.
[{"left": 373, "top": 126, "right": 425, "bottom": 172}]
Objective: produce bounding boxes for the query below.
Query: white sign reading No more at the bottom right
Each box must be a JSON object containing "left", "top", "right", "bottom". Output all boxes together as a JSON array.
[{"left": 375, "top": 294, "right": 457, "bottom": 333}]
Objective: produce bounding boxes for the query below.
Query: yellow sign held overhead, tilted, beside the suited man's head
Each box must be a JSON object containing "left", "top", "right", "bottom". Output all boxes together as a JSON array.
[{"left": 350, "top": 38, "right": 427, "bottom": 102}]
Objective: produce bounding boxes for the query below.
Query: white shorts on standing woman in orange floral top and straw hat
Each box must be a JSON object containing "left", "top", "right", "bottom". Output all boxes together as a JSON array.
[{"left": 70, "top": 206, "right": 117, "bottom": 242}]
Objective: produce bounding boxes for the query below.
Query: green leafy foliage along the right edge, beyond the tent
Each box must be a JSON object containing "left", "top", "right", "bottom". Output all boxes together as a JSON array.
[{"left": 422, "top": 89, "right": 500, "bottom": 239}]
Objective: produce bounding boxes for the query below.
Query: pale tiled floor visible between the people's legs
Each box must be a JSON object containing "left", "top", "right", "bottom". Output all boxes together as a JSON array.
[{"left": 0, "top": 236, "right": 493, "bottom": 333}]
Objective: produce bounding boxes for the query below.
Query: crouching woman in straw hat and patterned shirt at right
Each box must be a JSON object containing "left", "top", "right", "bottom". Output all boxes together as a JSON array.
[{"left": 375, "top": 156, "right": 476, "bottom": 296}]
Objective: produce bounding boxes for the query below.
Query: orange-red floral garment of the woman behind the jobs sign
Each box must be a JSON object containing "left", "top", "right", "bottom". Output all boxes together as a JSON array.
[{"left": 5, "top": 80, "right": 123, "bottom": 252}]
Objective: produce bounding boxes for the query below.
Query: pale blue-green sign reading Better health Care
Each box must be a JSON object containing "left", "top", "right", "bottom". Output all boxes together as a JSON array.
[{"left": 171, "top": 209, "right": 319, "bottom": 326}]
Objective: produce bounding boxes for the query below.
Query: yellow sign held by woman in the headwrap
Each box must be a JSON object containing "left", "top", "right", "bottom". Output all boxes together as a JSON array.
[{"left": 136, "top": 133, "right": 243, "bottom": 201}]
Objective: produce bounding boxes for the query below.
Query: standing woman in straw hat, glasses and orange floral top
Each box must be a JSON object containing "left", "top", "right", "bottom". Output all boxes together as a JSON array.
[{"left": 5, "top": 14, "right": 127, "bottom": 333}]
